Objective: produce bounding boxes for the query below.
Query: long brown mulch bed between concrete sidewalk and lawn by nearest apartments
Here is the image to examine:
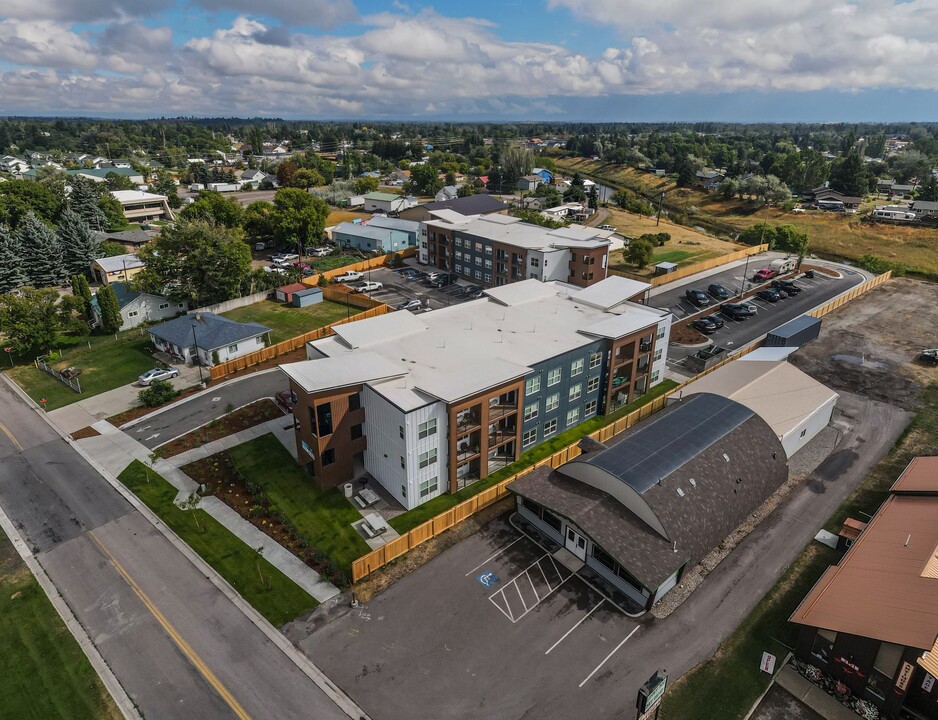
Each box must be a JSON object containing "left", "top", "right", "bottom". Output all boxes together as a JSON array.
[{"left": 182, "top": 450, "right": 351, "bottom": 587}]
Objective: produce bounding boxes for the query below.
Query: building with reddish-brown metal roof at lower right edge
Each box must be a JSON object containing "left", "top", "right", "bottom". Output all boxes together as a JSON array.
[{"left": 790, "top": 457, "right": 938, "bottom": 720}]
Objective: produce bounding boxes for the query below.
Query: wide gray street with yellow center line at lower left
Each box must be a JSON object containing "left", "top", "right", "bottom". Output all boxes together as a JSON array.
[{"left": 0, "top": 382, "right": 347, "bottom": 720}]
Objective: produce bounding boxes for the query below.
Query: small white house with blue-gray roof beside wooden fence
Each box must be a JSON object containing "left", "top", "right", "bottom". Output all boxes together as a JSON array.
[{"left": 147, "top": 312, "right": 270, "bottom": 367}]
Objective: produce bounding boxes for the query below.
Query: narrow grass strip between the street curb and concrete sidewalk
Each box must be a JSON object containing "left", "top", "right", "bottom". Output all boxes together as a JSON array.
[{"left": 118, "top": 460, "right": 318, "bottom": 627}]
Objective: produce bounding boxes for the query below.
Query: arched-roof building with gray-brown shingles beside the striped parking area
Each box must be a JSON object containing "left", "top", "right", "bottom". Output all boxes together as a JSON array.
[{"left": 508, "top": 393, "right": 788, "bottom": 612}]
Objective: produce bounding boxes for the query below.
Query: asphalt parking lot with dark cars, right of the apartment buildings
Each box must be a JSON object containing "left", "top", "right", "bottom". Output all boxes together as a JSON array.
[{"left": 650, "top": 268, "right": 866, "bottom": 374}]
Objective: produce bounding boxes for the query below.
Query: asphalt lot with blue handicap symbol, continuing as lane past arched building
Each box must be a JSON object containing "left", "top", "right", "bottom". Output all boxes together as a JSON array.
[{"left": 287, "top": 394, "right": 911, "bottom": 720}]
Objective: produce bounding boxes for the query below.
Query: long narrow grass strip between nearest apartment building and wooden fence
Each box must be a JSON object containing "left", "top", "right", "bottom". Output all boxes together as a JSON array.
[{"left": 388, "top": 380, "right": 677, "bottom": 534}]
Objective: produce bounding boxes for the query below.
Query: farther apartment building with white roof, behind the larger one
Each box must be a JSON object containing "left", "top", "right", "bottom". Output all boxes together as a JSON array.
[{"left": 419, "top": 209, "right": 610, "bottom": 287}]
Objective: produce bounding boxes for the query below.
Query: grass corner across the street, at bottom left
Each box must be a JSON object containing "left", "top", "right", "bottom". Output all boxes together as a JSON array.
[{"left": 0, "top": 532, "right": 121, "bottom": 720}]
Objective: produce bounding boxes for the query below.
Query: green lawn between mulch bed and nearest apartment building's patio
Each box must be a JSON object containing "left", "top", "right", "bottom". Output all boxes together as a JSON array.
[{"left": 229, "top": 435, "right": 371, "bottom": 573}]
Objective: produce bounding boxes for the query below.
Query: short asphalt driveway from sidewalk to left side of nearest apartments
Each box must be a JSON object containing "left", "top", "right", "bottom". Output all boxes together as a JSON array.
[{"left": 126, "top": 370, "right": 290, "bottom": 449}]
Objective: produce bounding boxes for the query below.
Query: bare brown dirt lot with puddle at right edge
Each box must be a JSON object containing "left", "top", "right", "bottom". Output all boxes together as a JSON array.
[{"left": 792, "top": 278, "right": 938, "bottom": 409}]
